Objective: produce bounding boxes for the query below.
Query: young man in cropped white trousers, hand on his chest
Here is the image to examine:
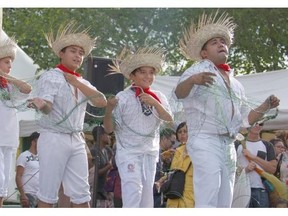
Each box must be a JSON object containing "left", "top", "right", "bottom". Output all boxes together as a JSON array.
[{"left": 29, "top": 22, "right": 107, "bottom": 207}]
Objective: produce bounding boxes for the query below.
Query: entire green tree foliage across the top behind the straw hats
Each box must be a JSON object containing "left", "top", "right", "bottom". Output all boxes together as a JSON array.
[{"left": 3, "top": 8, "right": 288, "bottom": 75}]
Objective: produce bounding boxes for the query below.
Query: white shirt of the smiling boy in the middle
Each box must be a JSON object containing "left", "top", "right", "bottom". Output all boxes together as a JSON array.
[{"left": 113, "top": 88, "right": 171, "bottom": 163}]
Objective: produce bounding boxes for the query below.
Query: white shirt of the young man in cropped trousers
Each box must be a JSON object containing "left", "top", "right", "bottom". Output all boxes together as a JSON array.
[{"left": 37, "top": 68, "right": 96, "bottom": 133}]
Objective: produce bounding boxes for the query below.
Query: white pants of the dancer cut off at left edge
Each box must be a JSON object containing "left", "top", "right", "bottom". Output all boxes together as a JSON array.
[{"left": 0, "top": 146, "right": 14, "bottom": 197}]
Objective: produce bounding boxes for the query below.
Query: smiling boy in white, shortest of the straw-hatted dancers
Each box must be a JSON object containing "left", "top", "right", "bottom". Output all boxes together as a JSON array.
[{"left": 104, "top": 47, "right": 172, "bottom": 208}]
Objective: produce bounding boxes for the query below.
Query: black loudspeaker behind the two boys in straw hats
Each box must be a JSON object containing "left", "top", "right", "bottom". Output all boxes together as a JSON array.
[{"left": 83, "top": 57, "right": 124, "bottom": 123}]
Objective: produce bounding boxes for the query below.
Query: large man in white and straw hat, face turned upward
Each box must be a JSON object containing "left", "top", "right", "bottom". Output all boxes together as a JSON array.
[{"left": 175, "top": 13, "right": 279, "bottom": 207}]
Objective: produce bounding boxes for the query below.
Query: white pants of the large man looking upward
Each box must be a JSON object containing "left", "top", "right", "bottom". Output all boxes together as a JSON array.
[{"left": 187, "top": 135, "right": 236, "bottom": 208}]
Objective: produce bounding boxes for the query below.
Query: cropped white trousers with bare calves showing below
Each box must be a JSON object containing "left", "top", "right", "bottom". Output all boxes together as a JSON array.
[{"left": 37, "top": 132, "right": 91, "bottom": 204}]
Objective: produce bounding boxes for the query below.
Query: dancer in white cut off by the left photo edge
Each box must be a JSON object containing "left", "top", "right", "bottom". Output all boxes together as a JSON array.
[{"left": 0, "top": 35, "right": 32, "bottom": 207}]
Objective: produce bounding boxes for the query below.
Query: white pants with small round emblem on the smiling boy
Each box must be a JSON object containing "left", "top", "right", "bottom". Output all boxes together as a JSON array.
[{"left": 117, "top": 155, "right": 157, "bottom": 208}]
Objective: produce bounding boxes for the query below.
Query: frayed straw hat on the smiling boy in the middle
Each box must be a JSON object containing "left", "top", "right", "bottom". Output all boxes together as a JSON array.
[{"left": 109, "top": 47, "right": 165, "bottom": 79}]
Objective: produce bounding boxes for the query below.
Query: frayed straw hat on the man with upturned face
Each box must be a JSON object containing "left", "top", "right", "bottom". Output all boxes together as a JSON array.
[{"left": 179, "top": 11, "right": 236, "bottom": 61}]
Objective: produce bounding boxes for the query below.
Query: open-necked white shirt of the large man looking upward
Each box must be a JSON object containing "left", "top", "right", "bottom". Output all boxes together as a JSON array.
[{"left": 178, "top": 60, "right": 250, "bottom": 143}]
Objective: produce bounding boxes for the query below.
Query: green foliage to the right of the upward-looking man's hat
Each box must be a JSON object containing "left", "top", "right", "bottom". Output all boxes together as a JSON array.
[{"left": 230, "top": 8, "right": 288, "bottom": 74}]
